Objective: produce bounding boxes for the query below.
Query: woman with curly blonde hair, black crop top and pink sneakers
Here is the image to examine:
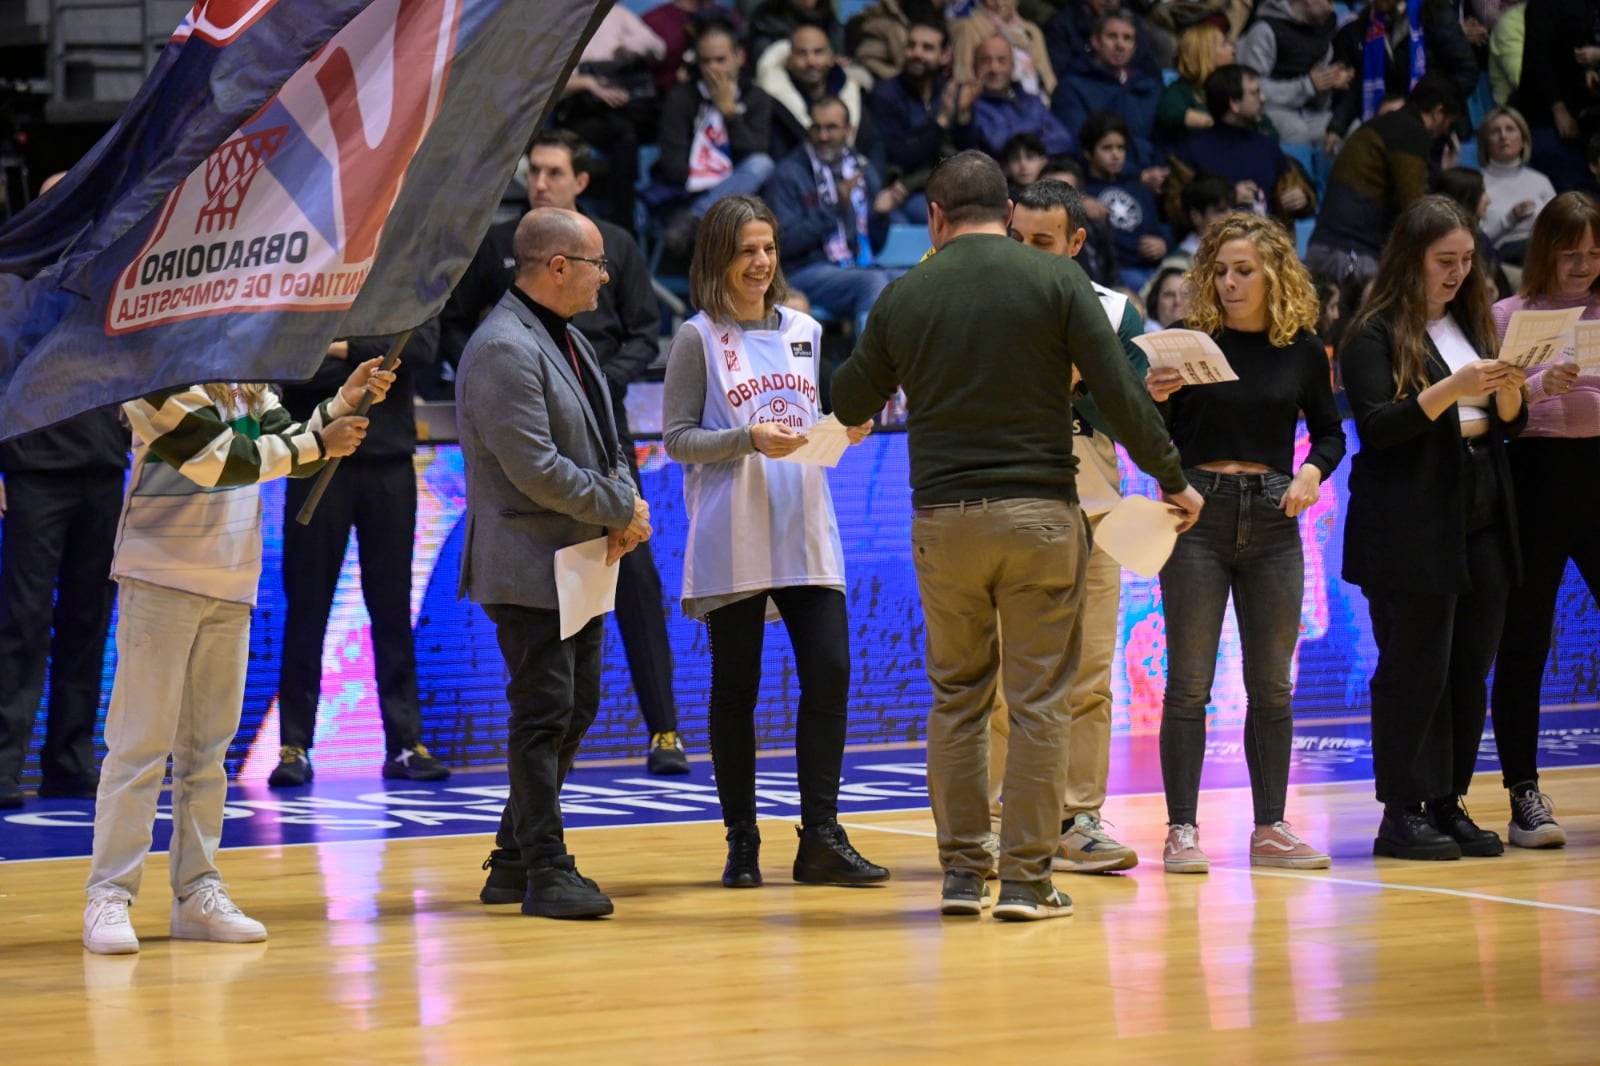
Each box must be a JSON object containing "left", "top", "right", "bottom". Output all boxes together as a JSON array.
[{"left": 1146, "top": 214, "right": 1344, "bottom": 874}]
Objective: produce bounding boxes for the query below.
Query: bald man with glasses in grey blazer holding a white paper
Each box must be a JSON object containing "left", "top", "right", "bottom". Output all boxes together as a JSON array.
[{"left": 456, "top": 208, "right": 650, "bottom": 917}]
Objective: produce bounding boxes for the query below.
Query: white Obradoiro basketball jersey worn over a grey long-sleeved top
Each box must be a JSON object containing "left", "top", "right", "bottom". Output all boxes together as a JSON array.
[{"left": 683, "top": 307, "right": 845, "bottom": 600}]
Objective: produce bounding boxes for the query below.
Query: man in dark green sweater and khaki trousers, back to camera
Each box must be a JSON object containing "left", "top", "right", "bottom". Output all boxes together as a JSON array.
[{"left": 832, "top": 152, "right": 1202, "bottom": 920}]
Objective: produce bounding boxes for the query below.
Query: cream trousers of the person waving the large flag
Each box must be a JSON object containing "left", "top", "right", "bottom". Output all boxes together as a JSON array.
[{"left": 86, "top": 579, "right": 250, "bottom": 901}]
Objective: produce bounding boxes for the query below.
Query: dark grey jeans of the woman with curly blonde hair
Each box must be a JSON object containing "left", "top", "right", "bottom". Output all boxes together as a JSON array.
[{"left": 1162, "top": 469, "right": 1306, "bottom": 826}]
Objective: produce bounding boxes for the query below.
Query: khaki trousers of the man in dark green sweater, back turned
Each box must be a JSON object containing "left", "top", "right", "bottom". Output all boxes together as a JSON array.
[{"left": 910, "top": 499, "right": 1088, "bottom": 882}]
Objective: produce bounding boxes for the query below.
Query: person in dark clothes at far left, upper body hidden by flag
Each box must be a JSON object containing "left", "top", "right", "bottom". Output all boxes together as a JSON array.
[{"left": 0, "top": 407, "right": 130, "bottom": 808}]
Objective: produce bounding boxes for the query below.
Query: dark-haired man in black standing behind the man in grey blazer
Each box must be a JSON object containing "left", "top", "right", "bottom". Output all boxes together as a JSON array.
[{"left": 440, "top": 130, "right": 690, "bottom": 773}]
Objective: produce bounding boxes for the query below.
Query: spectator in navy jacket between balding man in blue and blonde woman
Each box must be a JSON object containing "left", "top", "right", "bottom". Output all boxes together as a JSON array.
[{"left": 1050, "top": 8, "right": 1162, "bottom": 170}]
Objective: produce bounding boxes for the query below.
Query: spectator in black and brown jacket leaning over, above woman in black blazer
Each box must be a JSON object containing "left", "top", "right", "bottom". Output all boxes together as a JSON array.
[{"left": 1306, "top": 74, "right": 1462, "bottom": 285}]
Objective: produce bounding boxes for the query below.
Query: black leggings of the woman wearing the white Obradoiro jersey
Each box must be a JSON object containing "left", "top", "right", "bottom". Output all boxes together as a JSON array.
[{"left": 706, "top": 586, "right": 850, "bottom": 826}]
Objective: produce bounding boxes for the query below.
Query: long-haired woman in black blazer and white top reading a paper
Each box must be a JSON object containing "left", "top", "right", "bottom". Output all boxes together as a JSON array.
[{"left": 1339, "top": 197, "right": 1528, "bottom": 860}]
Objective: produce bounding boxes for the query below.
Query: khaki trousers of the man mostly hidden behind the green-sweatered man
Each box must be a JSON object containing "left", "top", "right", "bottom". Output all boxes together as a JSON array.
[{"left": 989, "top": 515, "right": 1122, "bottom": 829}]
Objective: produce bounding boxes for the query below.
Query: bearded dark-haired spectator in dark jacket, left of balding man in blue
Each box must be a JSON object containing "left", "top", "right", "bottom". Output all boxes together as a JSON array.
[{"left": 867, "top": 16, "right": 978, "bottom": 224}]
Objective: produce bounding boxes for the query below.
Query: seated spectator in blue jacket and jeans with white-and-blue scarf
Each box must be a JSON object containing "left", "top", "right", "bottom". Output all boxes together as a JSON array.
[{"left": 763, "top": 96, "right": 906, "bottom": 336}]
